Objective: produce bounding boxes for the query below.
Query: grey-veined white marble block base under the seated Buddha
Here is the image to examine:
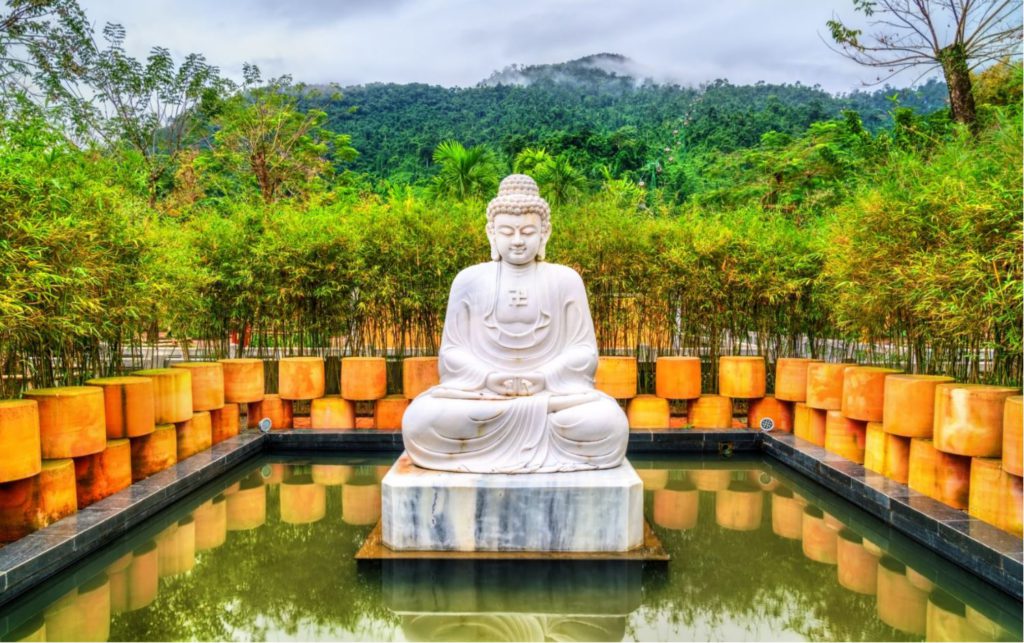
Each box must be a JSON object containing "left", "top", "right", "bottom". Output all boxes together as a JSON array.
[{"left": 381, "top": 454, "right": 643, "bottom": 552}]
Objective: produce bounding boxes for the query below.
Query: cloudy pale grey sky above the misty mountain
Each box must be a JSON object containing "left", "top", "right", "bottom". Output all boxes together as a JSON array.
[{"left": 82, "top": 0, "right": 937, "bottom": 91}]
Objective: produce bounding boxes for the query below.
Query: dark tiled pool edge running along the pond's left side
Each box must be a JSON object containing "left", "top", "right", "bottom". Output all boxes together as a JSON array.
[{"left": 0, "top": 432, "right": 264, "bottom": 605}]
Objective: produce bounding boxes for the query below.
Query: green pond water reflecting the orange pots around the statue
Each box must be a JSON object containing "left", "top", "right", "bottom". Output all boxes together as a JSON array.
[{"left": 0, "top": 457, "right": 1022, "bottom": 641}]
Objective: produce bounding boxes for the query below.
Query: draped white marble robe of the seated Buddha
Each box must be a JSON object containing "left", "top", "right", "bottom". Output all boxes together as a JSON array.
[{"left": 402, "top": 261, "right": 629, "bottom": 473}]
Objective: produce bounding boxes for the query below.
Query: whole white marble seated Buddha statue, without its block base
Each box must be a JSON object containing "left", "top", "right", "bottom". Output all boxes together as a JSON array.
[{"left": 402, "top": 174, "right": 629, "bottom": 473}]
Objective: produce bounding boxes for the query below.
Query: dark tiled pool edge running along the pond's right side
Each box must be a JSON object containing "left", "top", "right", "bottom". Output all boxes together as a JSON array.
[{"left": 761, "top": 433, "right": 1024, "bottom": 600}]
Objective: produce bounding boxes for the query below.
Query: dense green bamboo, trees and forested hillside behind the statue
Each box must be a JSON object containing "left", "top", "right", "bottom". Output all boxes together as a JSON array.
[{"left": 0, "top": 5, "right": 1022, "bottom": 395}]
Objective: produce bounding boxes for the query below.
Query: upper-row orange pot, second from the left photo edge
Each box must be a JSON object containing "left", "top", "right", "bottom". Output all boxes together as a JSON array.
[{"left": 25, "top": 386, "right": 106, "bottom": 460}]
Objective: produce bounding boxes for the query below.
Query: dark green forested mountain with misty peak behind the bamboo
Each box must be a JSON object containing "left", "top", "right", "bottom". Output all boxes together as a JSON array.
[{"left": 303, "top": 53, "right": 946, "bottom": 181}]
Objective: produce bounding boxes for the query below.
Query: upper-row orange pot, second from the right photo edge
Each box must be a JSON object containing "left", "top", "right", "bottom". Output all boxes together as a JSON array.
[{"left": 934, "top": 384, "right": 1019, "bottom": 458}]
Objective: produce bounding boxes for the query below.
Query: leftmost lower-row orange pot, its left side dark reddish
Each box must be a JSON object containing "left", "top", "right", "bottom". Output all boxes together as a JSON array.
[{"left": 0, "top": 459, "right": 78, "bottom": 543}]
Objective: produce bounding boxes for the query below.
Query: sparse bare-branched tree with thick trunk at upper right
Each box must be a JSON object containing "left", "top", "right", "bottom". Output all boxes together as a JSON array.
[{"left": 827, "top": 0, "right": 1021, "bottom": 128}]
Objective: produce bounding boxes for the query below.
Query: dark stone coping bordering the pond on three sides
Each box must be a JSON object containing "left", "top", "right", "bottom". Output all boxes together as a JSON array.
[{"left": 0, "top": 429, "right": 1024, "bottom": 604}]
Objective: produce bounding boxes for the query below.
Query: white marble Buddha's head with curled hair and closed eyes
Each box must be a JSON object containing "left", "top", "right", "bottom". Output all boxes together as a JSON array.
[{"left": 487, "top": 174, "right": 551, "bottom": 265}]
